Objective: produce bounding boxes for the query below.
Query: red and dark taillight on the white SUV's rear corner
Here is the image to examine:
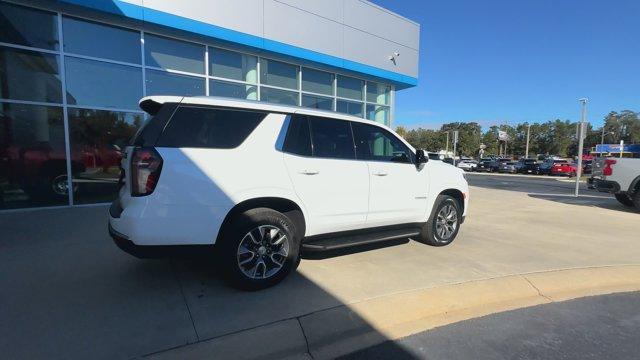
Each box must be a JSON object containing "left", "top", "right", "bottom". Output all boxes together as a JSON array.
[{"left": 131, "top": 148, "right": 162, "bottom": 196}]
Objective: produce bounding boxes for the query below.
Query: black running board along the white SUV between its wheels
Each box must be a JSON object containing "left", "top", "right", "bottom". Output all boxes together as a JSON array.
[{"left": 302, "top": 227, "right": 420, "bottom": 251}]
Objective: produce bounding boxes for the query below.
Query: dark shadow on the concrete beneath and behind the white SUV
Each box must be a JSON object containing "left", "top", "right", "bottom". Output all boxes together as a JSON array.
[{"left": 0, "top": 206, "right": 416, "bottom": 359}]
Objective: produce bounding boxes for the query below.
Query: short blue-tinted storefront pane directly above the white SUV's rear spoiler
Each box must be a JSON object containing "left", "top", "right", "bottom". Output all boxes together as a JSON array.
[{"left": 145, "top": 69, "right": 205, "bottom": 96}]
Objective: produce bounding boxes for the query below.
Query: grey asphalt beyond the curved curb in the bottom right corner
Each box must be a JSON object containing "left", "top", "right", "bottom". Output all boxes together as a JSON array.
[{"left": 342, "top": 292, "right": 640, "bottom": 360}]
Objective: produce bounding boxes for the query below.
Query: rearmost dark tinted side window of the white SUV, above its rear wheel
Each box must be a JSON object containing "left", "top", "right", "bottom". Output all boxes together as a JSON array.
[{"left": 156, "top": 106, "right": 267, "bottom": 149}]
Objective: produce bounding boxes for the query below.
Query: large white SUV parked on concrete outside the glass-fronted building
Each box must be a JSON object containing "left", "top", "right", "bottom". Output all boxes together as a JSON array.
[{"left": 109, "top": 96, "right": 469, "bottom": 289}]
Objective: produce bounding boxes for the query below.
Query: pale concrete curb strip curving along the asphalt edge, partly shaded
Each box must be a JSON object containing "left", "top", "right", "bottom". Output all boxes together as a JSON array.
[{"left": 145, "top": 265, "right": 640, "bottom": 360}]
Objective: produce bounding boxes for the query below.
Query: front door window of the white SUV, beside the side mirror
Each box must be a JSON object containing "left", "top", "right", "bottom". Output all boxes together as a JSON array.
[{"left": 351, "top": 122, "right": 414, "bottom": 164}]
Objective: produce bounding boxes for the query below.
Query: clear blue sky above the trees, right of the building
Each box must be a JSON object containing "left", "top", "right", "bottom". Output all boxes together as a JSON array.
[{"left": 374, "top": 0, "right": 640, "bottom": 128}]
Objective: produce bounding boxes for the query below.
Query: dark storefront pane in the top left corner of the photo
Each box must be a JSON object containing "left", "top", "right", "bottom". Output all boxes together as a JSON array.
[{"left": 0, "top": 2, "right": 59, "bottom": 50}]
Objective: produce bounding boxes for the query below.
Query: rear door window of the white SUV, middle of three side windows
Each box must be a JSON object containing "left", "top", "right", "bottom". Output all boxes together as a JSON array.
[{"left": 309, "top": 116, "right": 356, "bottom": 160}]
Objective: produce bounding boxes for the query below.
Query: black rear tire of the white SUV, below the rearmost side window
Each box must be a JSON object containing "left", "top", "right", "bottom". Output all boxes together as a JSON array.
[{"left": 217, "top": 208, "right": 300, "bottom": 291}]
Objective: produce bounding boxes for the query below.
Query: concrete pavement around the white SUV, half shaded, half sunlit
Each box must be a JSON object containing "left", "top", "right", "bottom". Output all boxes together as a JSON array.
[{"left": 0, "top": 188, "right": 640, "bottom": 359}]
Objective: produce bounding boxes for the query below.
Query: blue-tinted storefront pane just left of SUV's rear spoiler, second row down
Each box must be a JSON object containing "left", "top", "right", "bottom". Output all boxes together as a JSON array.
[{"left": 65, "top": 56, "right": 142, "bottom": 110}]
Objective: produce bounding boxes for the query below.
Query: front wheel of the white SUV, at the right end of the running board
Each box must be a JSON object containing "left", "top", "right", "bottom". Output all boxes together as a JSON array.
[{"left": 420, "top": 195, "right": 462, "bottom": 246}]
